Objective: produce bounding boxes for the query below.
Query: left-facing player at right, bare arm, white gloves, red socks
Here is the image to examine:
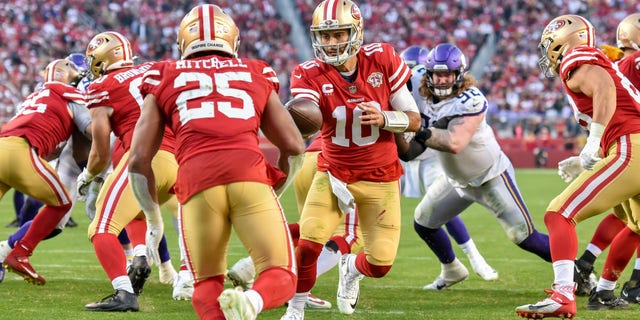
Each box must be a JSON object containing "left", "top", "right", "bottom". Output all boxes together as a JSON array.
[{"left": 516, "top": 15, "right": 640, "bottom": 318}]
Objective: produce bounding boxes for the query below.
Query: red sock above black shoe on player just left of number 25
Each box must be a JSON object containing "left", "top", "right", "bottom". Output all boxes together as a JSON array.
[{"left": 91, "top": 233, "right": 127, "bottom": 281}]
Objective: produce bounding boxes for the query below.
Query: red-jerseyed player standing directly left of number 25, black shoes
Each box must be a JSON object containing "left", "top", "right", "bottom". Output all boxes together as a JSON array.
[{"left": 78, "top": 31, "right": 178, "bottom": 311}]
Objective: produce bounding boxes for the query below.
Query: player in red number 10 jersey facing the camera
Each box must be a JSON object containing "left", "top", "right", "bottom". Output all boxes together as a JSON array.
[{"left": 282, "top": 0, "right": 420, "bottom": 319}]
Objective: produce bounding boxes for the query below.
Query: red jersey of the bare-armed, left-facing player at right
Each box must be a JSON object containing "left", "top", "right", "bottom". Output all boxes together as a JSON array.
[{"left": 560, "top": 46, "right": 640, "bottom": 152}]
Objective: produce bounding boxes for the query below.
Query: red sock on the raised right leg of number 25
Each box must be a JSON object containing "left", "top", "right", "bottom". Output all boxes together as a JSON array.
[{"left": 252, "top": 268, "right": 297, "bottom": 310}]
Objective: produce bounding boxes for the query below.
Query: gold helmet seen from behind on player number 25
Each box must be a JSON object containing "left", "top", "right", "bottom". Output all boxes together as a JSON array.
[{"left": 178, "top": 4, "right": 240, "bottom": 59}]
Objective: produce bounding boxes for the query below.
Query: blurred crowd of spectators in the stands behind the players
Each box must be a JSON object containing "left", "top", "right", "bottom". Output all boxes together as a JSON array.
[{"left": 0, "top": 0, "right": 640, "bottom": 148}]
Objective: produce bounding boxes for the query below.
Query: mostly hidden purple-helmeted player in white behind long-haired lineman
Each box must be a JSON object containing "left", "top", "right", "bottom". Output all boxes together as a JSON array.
[{"left": 396, "top": 46, "right": 498, "bottom": 284}]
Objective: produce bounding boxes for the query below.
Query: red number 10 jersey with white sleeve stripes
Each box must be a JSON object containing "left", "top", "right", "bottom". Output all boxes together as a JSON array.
[{"left": 291, "top": 43, "right": 411, "bottom": 183}]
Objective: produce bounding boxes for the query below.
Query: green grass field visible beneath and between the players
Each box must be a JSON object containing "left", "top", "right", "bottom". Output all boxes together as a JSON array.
[{"left": 0, "top": 170, "right": 640, "bottom": 320}]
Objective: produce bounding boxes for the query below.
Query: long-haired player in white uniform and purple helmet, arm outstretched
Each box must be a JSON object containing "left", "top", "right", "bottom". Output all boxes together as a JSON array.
[{"left": 398, "top": 43, "right": 550, "bottom": 290}]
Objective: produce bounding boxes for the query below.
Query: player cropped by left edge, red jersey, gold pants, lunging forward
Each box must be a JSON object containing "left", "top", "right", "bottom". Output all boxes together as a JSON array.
[{"left": 0, "top": 60, "right": 91, "bottom": 285}]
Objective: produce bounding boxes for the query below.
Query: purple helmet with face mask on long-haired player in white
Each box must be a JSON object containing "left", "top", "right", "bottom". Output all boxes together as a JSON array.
[{"left": 424, "top": 43, "right": 467, "bottom": 98}]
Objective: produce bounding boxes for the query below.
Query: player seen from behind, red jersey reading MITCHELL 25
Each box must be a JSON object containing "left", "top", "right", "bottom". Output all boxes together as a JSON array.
[{"left": 129, "top": 4, "right": 304, "bottom": 319}]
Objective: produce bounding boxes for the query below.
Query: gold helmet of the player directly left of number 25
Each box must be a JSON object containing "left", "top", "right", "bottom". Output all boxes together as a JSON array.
[{"left": 85, "top": 31, "right": 133, "bottom": 79}]
